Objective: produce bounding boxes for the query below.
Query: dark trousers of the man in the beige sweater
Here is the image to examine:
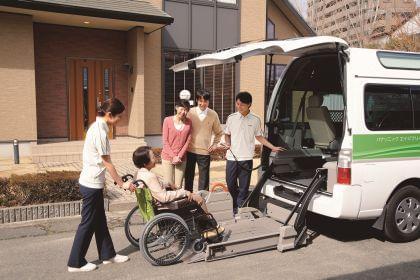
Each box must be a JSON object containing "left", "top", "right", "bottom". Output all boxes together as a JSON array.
[{"left": 185, "top": 152, "right": 210, "bottom": 192}]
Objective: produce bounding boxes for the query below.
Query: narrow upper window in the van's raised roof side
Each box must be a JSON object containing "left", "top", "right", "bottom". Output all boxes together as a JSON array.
[{"left": 377, "top": 51, "right": 420, "bottom": 70}]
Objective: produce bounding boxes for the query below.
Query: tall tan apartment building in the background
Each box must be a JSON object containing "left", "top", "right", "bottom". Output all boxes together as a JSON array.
[{"left": 307, "top": 0, "right": 416, "bottom": 47}]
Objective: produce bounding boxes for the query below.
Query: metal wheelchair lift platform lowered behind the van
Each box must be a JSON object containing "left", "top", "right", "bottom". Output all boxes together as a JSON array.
[{"left": 187, "top": 169, "right": 327, "bottom": 263}]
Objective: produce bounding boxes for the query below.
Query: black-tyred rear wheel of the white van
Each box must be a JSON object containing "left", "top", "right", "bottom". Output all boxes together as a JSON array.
[{"left": 384, "top": 185, "right": 420, "bottom": 242}]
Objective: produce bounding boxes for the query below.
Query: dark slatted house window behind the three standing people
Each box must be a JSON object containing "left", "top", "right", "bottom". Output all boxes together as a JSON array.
[{"left": 164, "top": 51, "right": 235, "bottom": 123}]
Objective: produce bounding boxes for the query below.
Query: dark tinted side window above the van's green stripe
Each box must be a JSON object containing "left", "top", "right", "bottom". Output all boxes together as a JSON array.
[{"left": 365, "top": 85, "right": 414, "bottom": 131}]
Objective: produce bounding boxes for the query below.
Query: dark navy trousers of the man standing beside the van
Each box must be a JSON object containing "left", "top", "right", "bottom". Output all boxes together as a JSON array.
[{"left": 226, "top": 160, "right": 253, "bottom": 214}]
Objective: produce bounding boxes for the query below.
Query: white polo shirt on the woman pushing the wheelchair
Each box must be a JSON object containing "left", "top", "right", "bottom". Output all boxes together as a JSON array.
[{"left": 79, "top": 117, "right": 111, "bottom": 189}]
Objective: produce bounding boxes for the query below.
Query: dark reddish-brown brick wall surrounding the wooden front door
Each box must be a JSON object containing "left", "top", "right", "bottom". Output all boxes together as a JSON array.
[{"left": 33, "top": 23, "right": 128, "bottom": 138}]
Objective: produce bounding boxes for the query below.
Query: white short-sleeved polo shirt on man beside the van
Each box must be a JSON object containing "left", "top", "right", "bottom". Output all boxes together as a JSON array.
[{"left": 225, "top": 112, "right": 262, "bottom": 161}]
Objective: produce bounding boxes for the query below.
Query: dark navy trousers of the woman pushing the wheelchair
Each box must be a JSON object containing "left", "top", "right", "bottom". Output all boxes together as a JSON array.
[{"left": 68, "top": 185, "right": 116, "bottom": 267}]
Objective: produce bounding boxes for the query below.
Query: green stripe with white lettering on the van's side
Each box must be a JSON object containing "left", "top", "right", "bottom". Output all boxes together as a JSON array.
[{"left": 353, "top": 133, "right": 420, "bottom": 160}]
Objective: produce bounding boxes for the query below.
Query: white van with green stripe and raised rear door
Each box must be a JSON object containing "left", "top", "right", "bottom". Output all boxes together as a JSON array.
[{"left": 173, "top": 36, "right": 420, "bottom": 242}]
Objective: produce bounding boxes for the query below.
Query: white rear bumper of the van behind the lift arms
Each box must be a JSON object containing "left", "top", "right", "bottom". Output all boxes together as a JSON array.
[{"left": 261, "top": 179, "right": 362, "bottom": 220}]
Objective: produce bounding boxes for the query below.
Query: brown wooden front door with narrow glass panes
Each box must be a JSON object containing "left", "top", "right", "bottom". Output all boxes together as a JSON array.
[{"left": 67, "top": 59, "right": 114, "bottom": 140}]
